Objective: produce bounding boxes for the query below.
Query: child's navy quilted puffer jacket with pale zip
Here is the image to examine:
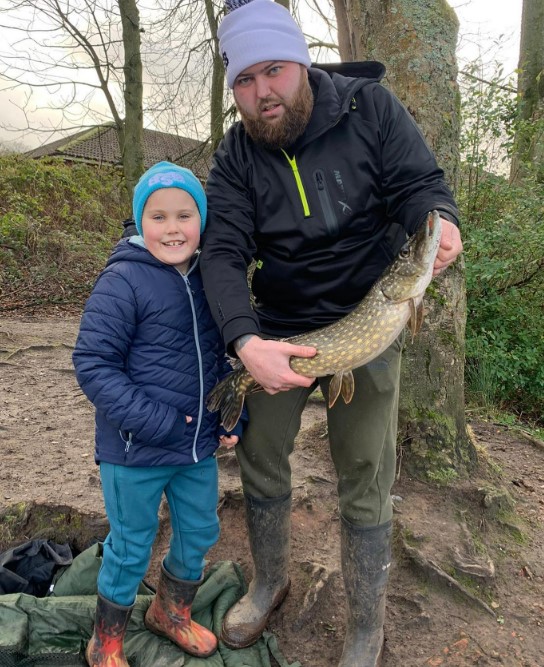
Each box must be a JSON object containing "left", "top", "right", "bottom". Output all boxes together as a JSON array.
[{"left": 73, "top": 237, "right": 240, "bottom": 466}]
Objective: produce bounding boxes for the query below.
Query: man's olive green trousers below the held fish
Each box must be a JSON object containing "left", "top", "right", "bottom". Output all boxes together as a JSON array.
[{"left": 236, "top": 335, "right": 404, "bottom": 527}]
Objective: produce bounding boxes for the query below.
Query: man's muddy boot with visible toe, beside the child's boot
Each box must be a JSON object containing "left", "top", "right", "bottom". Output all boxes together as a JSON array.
[{"left": 221, "top": 494, "right": 291, "bottom": 648}]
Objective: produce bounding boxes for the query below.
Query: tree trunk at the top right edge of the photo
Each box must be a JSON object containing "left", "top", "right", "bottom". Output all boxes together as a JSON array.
[{"left": 510, "top": 0, "right": 544, "bottom": 183}]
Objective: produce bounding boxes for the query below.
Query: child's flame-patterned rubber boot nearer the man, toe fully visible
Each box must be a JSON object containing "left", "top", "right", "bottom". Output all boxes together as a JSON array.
[{"left": 144, "top": 564, "right": 217, "bottom": 658}]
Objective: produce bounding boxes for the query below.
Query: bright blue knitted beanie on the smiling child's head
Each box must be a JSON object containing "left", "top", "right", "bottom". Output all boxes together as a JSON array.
[{"left": 132, "top": 162, "right": 208, "bottom": 236}]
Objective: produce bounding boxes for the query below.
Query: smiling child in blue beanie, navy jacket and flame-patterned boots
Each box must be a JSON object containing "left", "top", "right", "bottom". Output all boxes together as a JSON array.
[{"left": 73, "top": 162, "right": 241, "bottom": 667}]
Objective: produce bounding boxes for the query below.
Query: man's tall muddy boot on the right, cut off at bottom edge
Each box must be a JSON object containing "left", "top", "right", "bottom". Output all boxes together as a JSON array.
[{"left": 338, "top": 517, "right": 391, "bottom": 667}]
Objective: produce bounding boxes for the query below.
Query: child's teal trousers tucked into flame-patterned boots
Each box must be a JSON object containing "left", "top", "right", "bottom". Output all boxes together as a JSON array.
[{"left": 98, "top": 456, "right": 219, "bottom": 606}]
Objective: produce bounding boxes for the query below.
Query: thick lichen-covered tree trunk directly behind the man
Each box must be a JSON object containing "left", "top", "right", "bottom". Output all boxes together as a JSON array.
[{"left": 335, "top": 0, "right": 476, "bottom": 477}]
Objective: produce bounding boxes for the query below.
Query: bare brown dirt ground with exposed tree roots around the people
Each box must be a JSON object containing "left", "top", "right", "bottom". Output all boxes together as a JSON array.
[{"left": 0, "top": 315, "right": 544, "bottom": 667}]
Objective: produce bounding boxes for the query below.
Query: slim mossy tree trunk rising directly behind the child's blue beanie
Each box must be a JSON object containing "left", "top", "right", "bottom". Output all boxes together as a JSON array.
[{"left": 117, "top": 0, "right": 144, "bottom": 200}]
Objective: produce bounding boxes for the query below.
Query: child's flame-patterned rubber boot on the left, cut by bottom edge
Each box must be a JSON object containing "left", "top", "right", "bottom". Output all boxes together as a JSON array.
[{"left": 85, "top": 595, "right": 134, "bottom": 667}]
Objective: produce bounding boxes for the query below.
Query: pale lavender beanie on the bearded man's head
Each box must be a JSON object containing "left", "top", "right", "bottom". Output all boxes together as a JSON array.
[{"left": 217, "top": 0, "right": 311, "bottom": 88}]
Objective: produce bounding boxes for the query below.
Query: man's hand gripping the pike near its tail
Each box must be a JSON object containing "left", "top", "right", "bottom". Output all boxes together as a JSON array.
[{"left": 234, "top": 336, "right": 317, "bottom": 394}]
